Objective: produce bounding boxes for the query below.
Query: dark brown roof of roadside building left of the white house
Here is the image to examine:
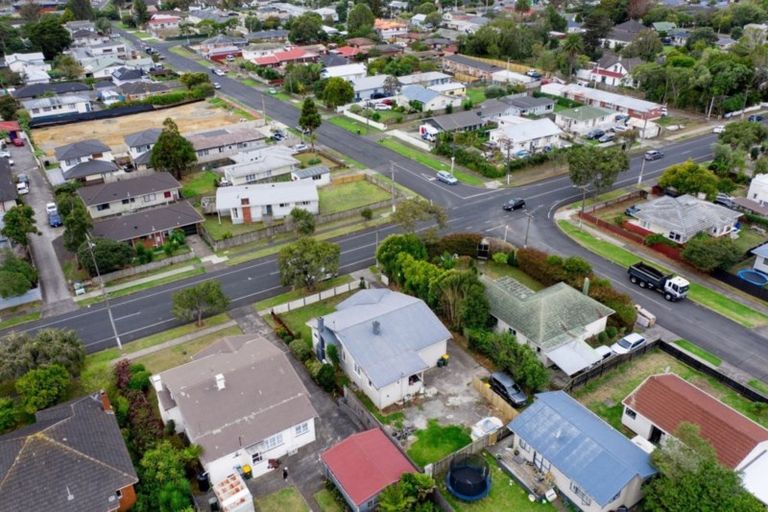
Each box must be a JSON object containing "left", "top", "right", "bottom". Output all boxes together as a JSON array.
[{"left": 93, "top": 201, "right": 203, "bottom": 242}]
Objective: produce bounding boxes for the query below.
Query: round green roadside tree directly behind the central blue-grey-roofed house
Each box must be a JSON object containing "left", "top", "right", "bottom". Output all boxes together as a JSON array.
[{"left": 277, "top": 237, "right": 341, "bottom": 290}]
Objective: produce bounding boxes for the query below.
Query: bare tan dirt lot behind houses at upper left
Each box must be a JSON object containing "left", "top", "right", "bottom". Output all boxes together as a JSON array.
[{"left": 32, "top": 101, "right": 249, "bottom": 155}]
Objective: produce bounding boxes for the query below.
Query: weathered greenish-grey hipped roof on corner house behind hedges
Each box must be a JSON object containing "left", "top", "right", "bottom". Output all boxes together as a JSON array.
[{"left": 480, "top": 275, "right": 613, "bottom": 351}]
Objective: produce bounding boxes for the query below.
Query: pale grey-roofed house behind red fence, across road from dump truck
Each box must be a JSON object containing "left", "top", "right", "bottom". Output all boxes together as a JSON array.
[{"left": 629, "top": 194, "right": 741, "bottom": 244}]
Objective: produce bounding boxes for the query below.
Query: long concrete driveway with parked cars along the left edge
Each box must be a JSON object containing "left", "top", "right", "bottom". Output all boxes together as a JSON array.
[{"left": 10, "top": 143, "right": 77, "bottom": 316}]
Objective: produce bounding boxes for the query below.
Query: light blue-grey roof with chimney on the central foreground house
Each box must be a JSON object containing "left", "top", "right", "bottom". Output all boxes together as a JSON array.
[{"left": 321, "top": 289, "right": 451, "bottom": 389}]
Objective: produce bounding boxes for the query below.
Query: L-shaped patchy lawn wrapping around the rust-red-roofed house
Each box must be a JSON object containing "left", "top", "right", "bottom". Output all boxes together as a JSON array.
[{"left": 573, "top": 350, "right": 768, "bottom": 434}]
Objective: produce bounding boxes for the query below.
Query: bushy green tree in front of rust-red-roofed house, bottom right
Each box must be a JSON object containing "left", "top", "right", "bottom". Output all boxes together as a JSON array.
[{"left": 643, "top": 423, "right": 765, "bottom": 512}]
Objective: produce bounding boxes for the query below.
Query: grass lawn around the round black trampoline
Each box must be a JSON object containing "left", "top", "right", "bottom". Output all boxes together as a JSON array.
[{"left": 436, "top": 452, "right": 557, "bottom": 512}]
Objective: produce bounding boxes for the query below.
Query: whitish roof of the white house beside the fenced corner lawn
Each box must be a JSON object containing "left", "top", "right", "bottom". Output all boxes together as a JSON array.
[{"left": 216, "top": 180, "right": 319, "bottom": 211}]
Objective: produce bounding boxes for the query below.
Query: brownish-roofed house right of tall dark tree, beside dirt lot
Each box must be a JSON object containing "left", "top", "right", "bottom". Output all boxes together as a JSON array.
[{"left": 186, "top": 122, "right": 267, "bottom": 162}]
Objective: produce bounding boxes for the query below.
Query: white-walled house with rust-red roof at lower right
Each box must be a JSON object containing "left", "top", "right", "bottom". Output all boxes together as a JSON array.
[{"left": 621, "top": 373, "right": 768, "bottom": 505}]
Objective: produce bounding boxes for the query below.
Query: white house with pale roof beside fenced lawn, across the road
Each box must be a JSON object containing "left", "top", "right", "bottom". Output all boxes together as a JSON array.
[{"left": 216, "top": 180, "right": 320, "bottom": 224}]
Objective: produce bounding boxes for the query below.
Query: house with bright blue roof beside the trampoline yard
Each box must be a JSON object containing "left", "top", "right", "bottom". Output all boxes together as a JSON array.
[{"left": 507, "top": 391, "right": 656, "bottom": 512}]
